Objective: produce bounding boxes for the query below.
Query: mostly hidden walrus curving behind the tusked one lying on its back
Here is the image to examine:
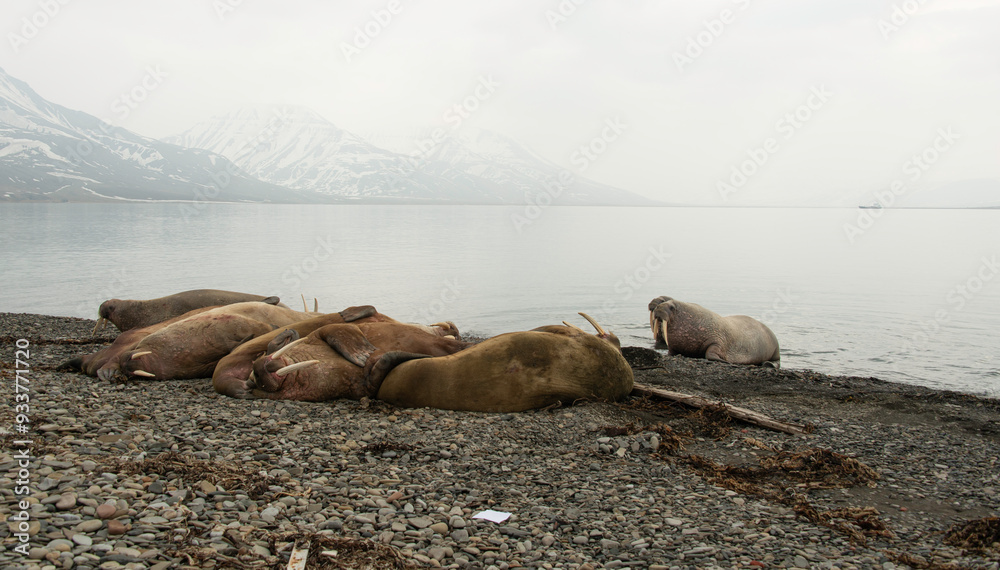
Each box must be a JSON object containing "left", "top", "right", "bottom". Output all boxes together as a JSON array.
[{"left": 212, "top": 305, "right": 458, "bottom": 398}]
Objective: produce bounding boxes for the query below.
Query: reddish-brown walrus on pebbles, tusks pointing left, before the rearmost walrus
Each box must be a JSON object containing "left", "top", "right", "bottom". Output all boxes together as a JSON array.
[{"left": 67, "top": 301, "right": 314, "bottom": 380}]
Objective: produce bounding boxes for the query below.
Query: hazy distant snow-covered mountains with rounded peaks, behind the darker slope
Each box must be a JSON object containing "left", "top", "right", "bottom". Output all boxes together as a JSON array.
[{"left": 165, "top": 106, "right": 653, "bottom": 205}]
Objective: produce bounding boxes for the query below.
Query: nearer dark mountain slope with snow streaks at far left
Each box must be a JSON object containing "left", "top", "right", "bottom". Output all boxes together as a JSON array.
[{"left": 0, "top": 69, "right": 315, "bottom": 202}]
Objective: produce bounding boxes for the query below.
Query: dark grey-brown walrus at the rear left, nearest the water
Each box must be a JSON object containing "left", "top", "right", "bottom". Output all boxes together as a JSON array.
[{"left": 94, "top": 289, "right": 288, "bottom": 333}]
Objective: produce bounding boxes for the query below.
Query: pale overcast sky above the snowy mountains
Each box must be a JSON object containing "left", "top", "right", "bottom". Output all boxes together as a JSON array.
[{"left": 0, "top": 0, "right": 1000, "bottom": 205}]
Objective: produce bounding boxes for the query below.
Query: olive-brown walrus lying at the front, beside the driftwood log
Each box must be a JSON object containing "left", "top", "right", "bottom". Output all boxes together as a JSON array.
[{"left": 370, "top": 312, "right": 633, "bottom": 412}]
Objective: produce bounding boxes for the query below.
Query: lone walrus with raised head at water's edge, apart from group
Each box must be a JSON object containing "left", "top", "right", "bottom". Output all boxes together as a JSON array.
[{"left": 649, "top": 296, "right": 781, "bottom": 368}]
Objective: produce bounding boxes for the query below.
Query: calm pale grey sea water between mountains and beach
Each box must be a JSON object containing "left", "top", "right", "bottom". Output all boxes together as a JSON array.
[{"left": 0, "top": 204, "right": 1000, "bottom": 397}]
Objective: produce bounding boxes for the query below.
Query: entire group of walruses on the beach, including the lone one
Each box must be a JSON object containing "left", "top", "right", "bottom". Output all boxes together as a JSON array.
[{"left": 65, "top": 289, "right": 780, "bottom": 412}]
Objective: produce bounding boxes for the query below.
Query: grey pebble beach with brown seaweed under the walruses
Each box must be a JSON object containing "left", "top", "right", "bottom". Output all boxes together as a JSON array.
[{"left": 0, "top": 314, "right": 1000, "bottom": 569}]
